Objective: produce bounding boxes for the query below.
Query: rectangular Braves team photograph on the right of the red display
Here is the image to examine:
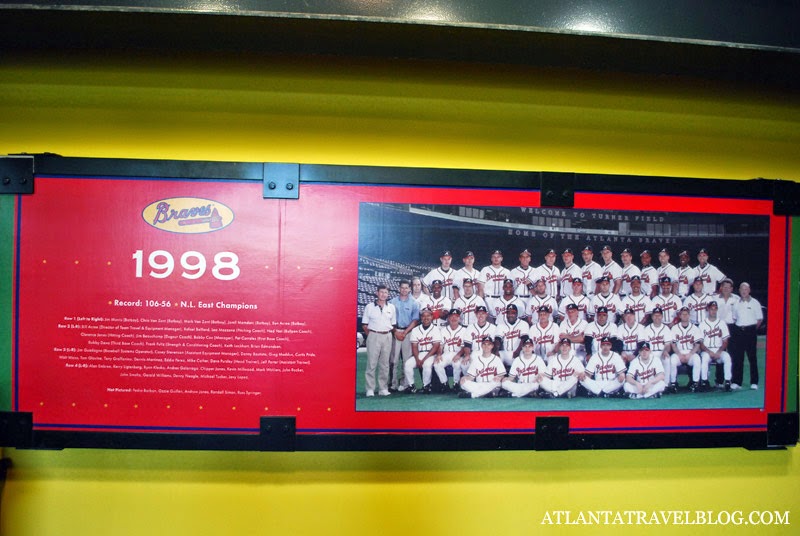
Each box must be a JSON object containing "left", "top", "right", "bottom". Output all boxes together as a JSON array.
[{"left": 355, "top": 203, "right": 769, "bottom": 411}]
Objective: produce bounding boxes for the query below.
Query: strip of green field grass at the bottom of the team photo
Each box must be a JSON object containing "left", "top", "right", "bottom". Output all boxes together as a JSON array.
[{"left": 355, "top": 337, "right": 765, "bottom": 412}]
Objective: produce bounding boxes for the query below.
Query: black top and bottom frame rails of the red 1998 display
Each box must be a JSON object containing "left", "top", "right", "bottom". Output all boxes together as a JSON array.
[{"left": 0, "top": 153, "right": 800, "bottom": 451}]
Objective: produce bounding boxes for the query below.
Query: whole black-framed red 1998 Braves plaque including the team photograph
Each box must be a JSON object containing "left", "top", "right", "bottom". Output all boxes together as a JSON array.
[{"left": 0, "top": 155, "right": 798, "bottom": 450}]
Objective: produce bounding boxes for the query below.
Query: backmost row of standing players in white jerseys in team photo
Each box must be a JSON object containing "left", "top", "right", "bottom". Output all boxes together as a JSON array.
[{"left": 422, "top": 245, "right": 726, "bottom": 301}]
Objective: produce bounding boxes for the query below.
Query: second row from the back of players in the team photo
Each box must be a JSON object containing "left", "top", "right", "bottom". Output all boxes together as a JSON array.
[{"left": 417, "top": 276, "right": 727, "bottom": 327}]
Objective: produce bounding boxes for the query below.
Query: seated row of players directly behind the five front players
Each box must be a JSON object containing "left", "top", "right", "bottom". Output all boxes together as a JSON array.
[{"left": 398, "top": 301, "right": 731, "bottom": 393}]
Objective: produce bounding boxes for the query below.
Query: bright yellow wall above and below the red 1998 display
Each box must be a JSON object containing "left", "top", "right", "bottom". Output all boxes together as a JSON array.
[{"left": 0, "top": 48, "right": 800, "bottom": 536}]
